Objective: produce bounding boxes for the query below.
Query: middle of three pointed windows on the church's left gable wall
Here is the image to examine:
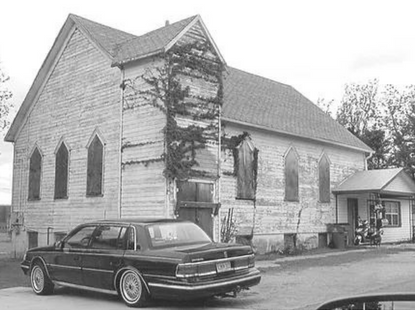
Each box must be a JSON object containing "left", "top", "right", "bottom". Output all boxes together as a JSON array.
[{"left": 55, "top": 143, "right": 68, "bottom": 199}]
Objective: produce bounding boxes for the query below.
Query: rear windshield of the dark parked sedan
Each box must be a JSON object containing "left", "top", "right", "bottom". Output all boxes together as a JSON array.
[{"left": 146, "top": 222, "right": 212, "bottom": 247}]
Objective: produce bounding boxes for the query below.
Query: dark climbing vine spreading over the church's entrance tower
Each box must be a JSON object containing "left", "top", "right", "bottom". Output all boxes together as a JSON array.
[{"left": 121, "top": 41, "right": 223, "bottom": 180}]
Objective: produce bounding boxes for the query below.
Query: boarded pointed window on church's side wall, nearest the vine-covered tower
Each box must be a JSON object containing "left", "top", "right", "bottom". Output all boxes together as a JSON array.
[{"left": 236, "top": 140, "right": 255, "bottom": 199}]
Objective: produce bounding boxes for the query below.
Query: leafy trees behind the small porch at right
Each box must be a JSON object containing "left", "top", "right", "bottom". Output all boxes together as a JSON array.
[{"left": 336, "top": 80, "right": 415, "bottom": 179}]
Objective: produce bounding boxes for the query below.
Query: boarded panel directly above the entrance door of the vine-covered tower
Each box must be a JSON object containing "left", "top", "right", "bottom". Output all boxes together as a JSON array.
[{"left": 177, "top": 182, "right": 213, "bottom": 202}]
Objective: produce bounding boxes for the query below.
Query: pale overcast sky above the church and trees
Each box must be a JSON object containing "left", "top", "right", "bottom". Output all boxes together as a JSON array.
[{"left": 0, "top": 0, "right": 415, "bottom": 204}]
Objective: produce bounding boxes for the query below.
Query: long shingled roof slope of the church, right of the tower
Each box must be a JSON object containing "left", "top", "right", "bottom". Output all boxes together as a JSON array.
[{"left": 223, "top": 67, "right": 372, "bottom": 152}]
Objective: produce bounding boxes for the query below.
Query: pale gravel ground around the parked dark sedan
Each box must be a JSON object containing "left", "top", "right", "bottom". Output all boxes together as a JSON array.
[{"left": 0, "top": 244, "right": 415, "bottom": 310}]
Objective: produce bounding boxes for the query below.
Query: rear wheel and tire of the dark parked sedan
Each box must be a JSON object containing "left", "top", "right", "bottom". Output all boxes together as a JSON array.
[{"left": 118, "top": 269, "right": 148, "bottom": 307}]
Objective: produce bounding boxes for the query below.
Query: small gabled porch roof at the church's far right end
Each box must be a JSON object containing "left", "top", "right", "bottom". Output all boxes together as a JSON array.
[{"left": 333, "top": 168, "right": 415, "bottom": 196}]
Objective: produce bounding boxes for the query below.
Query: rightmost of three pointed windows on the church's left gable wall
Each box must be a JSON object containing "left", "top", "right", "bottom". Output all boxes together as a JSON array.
[{"left": 86, "top": 136, "right": 104, "bottom": 196}]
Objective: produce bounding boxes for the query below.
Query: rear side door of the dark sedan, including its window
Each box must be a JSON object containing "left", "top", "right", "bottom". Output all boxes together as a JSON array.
[{"left": 82, "top": 224, "right": 127, "bottom": 290}]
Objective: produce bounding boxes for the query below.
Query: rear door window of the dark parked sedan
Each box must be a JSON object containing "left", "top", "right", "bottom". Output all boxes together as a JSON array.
[{"left": 91, "top": 225, "right": 126, "bottom": 250}]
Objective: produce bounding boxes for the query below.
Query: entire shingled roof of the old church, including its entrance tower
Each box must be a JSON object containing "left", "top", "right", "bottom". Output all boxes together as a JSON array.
[{"left": 5, "top": 14, "right": 372, "bottom": 152}]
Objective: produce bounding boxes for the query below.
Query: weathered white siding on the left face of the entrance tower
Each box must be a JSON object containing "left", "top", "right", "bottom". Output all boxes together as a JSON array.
[{"left": 121, "top": 59, "right": 166, "bottom": 217}]
